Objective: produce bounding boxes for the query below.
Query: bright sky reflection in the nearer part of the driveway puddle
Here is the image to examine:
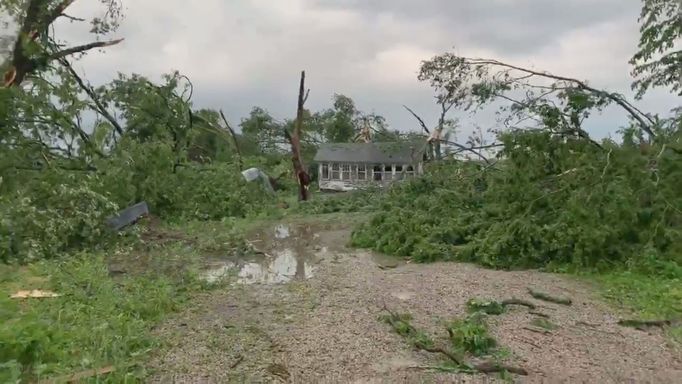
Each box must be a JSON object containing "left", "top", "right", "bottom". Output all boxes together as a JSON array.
[{"left": 204, "top": 249, "right": 313, "bottom": 284}]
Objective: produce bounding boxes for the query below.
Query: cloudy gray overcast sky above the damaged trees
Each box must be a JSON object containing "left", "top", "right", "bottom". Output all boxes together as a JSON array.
[{"left": 49, "top": 0, "right": 681, "bottom": 140}]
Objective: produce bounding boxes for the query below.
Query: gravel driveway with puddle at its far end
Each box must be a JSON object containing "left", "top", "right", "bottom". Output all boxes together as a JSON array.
[{"left": 150, "top": 220, "right": 682, "bottom": 383}]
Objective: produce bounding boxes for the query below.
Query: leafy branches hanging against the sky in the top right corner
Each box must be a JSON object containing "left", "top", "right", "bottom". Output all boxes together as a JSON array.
[{"left": 630, "top": 0, "right": 682, "bottom": 98}]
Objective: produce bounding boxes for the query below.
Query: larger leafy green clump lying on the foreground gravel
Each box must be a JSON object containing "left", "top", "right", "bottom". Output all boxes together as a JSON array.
[{"left": 447, "top": 312, "right": 497, "bottom": 356}]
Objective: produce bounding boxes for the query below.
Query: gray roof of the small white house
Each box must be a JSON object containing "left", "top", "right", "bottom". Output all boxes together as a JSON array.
[{"left": 314, "top": 142, "right": 424, "bottom": 164}]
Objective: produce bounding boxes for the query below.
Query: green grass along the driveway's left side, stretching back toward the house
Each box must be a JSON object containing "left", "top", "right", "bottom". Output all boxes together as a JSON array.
[{"left": 0, "top": 196, "right": 370, "bottom": 383}]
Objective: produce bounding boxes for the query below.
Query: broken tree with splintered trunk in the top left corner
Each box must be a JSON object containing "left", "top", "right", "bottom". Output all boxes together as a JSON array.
[{"left": 0, "top": 0, "right": 123, "bottom": 87}]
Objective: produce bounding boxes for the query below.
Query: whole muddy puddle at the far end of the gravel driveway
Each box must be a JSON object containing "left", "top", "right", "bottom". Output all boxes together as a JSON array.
[{"left": 203, "top": 224, "right": 328, "bottom": 284}]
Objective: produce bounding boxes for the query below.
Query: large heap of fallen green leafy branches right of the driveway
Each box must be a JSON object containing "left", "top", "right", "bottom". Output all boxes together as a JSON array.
[{"left": 352, "top": 131, "right": 682, "bottom": 271}]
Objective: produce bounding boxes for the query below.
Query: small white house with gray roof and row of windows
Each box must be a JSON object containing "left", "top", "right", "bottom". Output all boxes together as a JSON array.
[{"left": 313, "top": 142, "right": 425, "bottom": 191}]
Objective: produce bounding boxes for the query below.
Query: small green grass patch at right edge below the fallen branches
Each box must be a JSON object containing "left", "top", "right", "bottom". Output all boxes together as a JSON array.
[{"left": 591, "top": 272, "right": 682, "bottom": 346}]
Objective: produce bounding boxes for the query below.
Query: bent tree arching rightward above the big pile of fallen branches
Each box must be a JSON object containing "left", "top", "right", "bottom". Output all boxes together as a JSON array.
[{"left": 420, "top": 53, "right": 656, "bottom": 147}]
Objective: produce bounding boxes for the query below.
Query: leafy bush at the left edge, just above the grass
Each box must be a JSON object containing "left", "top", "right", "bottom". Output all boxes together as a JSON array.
[{"left": 0, "top": 171, "right": 117, "bottom": 262}]
